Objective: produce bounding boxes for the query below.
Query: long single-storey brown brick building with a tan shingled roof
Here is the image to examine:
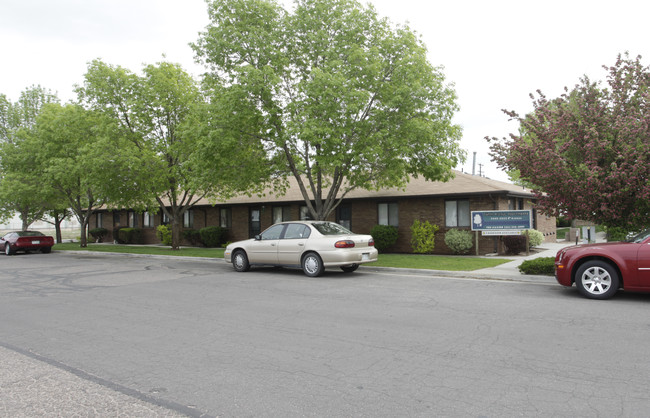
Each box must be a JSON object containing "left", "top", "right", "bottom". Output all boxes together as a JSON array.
[{"left": 89, "top": 172, "right": 556, "bottom": 254}]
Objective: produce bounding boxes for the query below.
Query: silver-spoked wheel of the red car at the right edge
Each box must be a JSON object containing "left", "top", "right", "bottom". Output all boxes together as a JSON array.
[{"left": 575, "top": 261, "right": 619, "bottom": 299}]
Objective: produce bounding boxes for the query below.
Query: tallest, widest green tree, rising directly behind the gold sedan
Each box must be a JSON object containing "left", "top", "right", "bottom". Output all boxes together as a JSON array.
[{"left": 193, "top": 0, "right": 464, "bottom": 219}]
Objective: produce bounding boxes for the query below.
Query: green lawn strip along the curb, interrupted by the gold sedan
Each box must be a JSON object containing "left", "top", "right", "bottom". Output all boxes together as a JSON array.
[{"left": 53, "top": 243, "right": 511, "bottom": 271}]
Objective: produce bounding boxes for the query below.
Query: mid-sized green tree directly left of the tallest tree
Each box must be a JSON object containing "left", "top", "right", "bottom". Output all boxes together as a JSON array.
[{"left": 77, "top": 60, "right": 266, "bottom": 249}]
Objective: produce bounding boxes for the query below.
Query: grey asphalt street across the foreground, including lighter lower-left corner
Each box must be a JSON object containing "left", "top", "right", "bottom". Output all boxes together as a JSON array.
[{"left": 0, "top": 252, "right": 650, "bottom": 417}]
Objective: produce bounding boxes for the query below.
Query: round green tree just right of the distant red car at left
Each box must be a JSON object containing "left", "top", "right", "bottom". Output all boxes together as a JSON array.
[{"left": 25, "top": 104, "right": 140, "bottom": 247}]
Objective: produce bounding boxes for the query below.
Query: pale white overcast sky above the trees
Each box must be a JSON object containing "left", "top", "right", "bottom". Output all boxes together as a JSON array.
[{"left": 0, "top": 0, "right": 650, "bottom": 180}]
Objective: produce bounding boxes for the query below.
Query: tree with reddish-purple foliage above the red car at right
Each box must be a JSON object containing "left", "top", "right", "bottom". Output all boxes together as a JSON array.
[{"left": 489, "top": 55, "right": 650, "bottom": 229}]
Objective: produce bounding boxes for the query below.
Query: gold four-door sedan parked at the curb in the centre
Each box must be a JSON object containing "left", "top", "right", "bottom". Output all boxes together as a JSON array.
[{"left": 224, "top": 221, "right": 378, "bottom": 277}]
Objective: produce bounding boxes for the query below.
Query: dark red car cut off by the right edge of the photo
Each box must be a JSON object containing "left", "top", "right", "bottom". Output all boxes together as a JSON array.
[{"left": 555, "top": 229, "right": 650, "bottom": 299}]
